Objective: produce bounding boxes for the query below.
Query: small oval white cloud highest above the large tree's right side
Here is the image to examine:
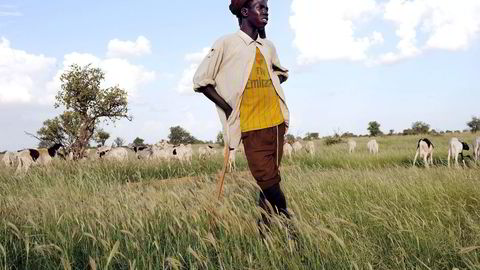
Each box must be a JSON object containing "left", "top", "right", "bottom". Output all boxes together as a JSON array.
[{"left": 107, "top": 36, "right": 152, "bottom": 57}]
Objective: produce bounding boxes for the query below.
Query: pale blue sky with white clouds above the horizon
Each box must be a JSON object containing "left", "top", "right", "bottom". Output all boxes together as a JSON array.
[{"left": 0, "top": 0, "right": 480, "bottom": 151}]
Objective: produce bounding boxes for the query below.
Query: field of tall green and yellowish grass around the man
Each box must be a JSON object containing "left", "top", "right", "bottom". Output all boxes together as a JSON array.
[{"left": 0, "top": 133, "right": 480, "bottom": 269}]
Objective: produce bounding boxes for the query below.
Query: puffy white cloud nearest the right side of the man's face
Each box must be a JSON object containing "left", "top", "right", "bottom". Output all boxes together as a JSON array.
[{"left": 290, "top": 0, "right": 383, "bottom": 64}]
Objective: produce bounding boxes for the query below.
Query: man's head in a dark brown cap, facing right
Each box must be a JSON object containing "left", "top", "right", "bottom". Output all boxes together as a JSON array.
[{"left": 229, "top": 0, "right": 268, "bottom": 38}]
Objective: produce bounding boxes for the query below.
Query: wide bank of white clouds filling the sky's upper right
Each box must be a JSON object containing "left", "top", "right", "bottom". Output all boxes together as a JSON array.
[{"left": 290, "top": 0, "right": 480, "bottom": 64}]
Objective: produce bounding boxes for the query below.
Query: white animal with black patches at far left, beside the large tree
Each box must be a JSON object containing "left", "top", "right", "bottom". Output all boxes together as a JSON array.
[{"left": 15, "top": 143, "right": 63, "bottom": 173}]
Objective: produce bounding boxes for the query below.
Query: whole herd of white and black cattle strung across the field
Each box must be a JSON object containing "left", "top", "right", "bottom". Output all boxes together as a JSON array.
[{"left": 2, "top": 137, "right": 480, "bottom": 173}]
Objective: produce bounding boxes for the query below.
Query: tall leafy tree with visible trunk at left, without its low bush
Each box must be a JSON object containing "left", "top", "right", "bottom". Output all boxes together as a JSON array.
[{"left": 55, "top": 64, "right": 132, "bottom": 159}]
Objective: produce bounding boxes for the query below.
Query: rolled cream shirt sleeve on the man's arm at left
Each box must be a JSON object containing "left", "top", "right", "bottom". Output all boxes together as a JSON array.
[{"left": 193, "top": 40, "right": 223, "bottom": 92}]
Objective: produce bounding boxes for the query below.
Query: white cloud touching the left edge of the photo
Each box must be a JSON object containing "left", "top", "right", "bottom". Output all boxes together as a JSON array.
[{"left": 0, "top": 37, "right": 56, "bottom": 103}]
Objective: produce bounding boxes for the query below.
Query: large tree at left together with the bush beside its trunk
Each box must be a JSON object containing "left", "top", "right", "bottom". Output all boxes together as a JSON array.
[{"left": 37, "top": 64, "right": 132, "bottom": 159}]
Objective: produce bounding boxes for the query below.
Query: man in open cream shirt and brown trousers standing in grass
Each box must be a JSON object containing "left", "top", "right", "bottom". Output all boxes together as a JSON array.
[{"left": 193, "top": 0, "right": 290, "bottom": 230}]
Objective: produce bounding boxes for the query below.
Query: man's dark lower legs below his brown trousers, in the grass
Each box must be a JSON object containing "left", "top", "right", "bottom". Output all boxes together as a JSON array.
[{"left": 258, "top": 183, "right": 290, "bottom": 226}]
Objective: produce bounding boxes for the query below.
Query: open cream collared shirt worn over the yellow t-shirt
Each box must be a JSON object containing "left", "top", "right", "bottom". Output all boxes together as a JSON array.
[{"left": 193, "top": 30, "right": 290, "bottom": 148}]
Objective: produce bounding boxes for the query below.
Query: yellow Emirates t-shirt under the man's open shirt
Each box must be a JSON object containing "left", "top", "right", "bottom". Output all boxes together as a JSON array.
[{"left": 240, "top": 48, "right": 284, "bottom": 132}]
